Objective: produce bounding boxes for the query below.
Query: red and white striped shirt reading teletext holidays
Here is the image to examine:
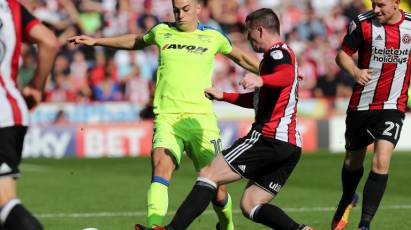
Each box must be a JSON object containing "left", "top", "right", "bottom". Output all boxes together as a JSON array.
[{"left": 342, "top": 11, "right": 411, "bottom": 112}]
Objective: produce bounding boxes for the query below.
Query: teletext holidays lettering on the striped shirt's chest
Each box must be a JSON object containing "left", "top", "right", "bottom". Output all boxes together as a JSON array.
[{"left": 373, "top": 47, "right": 410, "bottom": 64}]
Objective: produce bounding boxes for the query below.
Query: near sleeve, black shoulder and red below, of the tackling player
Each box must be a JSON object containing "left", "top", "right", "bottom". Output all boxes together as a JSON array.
[{"left": 261, "top": 48, "right": 295, "bottom": 88}]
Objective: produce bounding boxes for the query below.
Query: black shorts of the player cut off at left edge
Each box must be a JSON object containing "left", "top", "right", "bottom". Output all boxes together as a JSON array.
[{"left": 0, "top": 126, "right": 27, "bottom": 178}]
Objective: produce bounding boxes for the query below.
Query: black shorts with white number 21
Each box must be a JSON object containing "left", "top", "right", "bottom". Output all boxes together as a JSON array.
[{"left": 345, "top": 109, "right": 405, "bottom": 150}]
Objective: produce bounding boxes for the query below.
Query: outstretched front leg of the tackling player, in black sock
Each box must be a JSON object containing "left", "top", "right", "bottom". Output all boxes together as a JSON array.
[{"left": 167, "top": 154, "right": 241, "bottom": 230}]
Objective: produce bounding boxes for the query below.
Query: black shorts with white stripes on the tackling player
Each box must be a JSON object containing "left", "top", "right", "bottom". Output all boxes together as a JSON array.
[{"left": 223, "top": 130, "right": 301, "bottom": 195}]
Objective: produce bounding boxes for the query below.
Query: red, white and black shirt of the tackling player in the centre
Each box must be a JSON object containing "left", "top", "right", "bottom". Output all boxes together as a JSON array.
[{"left": 224, "top": 42, "right": 301, "bottom": 147}]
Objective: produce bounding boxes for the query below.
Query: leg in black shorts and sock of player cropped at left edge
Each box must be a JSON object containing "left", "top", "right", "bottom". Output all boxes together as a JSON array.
[{"left": 0, "top": 127, "right": 43, "bottom": 230}]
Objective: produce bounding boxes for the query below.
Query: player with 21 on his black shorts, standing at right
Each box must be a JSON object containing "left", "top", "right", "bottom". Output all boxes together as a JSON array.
[{"left": 331, "top": 0, "right": 411, "bottom": 230}]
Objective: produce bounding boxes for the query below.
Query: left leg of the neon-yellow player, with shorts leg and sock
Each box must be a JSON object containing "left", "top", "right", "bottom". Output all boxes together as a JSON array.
[{"left": 147, "top": 115, "right": 183, "bottom": 227}]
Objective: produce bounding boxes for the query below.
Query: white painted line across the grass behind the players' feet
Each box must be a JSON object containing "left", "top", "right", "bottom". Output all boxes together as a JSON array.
[{"left": 36, "top": 205, "right": 411, "bottom": 219}]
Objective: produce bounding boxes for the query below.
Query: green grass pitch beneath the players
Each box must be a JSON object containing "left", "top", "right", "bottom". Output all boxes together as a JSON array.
[{"left": 18, "top": 152, "right": 411, "bottom": 230}]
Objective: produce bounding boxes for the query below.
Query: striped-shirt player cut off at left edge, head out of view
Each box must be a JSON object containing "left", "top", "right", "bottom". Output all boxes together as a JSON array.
[{"left": 0, "top": 0, "right": 57, "bottom": 230}]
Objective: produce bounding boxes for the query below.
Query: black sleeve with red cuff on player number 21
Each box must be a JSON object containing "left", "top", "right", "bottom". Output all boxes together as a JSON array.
[{"left": 341, "top": 18, "right": 363, "bottom": 55}]
